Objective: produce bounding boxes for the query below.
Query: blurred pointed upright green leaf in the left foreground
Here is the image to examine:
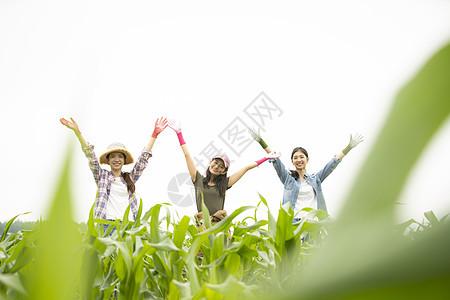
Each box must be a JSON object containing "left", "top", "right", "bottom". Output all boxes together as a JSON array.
[{"left": 29, "top": 141, "right": 81, "bottom": 300}]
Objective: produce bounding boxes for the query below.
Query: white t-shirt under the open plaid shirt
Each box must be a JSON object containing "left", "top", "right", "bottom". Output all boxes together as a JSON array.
[{"left": 106, "top": 177, "right": 134, "bottom": 220}]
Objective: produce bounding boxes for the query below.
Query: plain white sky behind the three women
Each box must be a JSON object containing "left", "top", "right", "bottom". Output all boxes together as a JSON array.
[{"left": 0, "top": 0, "right": 450, "bottom": 221}]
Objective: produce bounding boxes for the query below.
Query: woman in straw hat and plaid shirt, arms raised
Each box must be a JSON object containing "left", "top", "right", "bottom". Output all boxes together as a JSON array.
[{"left": 60, "top": 118, "right": 167, "bottom": 220}]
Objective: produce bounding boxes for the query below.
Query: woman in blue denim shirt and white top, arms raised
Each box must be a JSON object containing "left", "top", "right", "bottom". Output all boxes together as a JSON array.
[{"left": 249, "top": 129, "right": 363, "bottom": 222}]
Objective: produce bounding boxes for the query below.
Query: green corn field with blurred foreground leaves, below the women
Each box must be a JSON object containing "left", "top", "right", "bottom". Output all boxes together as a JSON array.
[{"left": 0, "top": 41, "right": 450, "bottom": 299}]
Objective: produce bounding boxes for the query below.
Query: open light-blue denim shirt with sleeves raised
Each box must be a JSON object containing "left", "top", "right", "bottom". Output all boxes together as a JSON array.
[{"left": 270, "top": 157, "right": 342, "bottom": 212}]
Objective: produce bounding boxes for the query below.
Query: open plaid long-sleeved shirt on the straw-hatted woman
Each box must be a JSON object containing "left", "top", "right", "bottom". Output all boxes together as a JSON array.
[{"left": 83, "top": 144, "right": 152, "bottom": 219}]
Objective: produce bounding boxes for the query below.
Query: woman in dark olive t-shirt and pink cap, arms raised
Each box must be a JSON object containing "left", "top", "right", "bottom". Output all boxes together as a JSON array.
[{"left": 168, "top": 120, "right": 280, "bottom": 220}]
